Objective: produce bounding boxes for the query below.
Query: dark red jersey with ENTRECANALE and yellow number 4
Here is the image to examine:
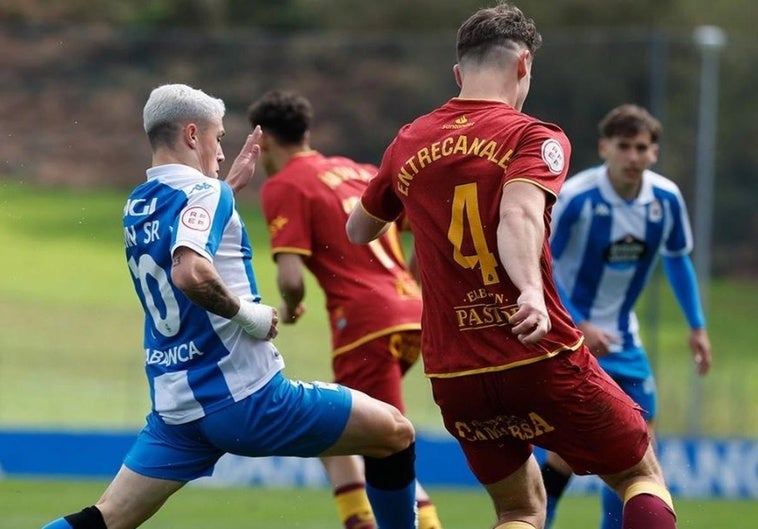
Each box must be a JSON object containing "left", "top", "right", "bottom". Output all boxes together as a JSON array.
[{"left": 362, "top": 98, "right": 581, "bottom": 377}]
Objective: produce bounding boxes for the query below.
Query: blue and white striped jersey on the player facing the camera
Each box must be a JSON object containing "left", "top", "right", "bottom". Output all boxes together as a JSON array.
[{"left": 551, "top": 165, "right": 692, "bottom": 352}]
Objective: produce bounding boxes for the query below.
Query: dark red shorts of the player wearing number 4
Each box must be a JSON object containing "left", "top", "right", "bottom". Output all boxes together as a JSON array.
[{"left": 431, "top": 346, "right": 650, "bottom": 484}]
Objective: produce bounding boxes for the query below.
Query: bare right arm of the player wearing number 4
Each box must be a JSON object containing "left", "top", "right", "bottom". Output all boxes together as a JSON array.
[{"left": 497, "top": 181, "right": 550, "bottom": 344}]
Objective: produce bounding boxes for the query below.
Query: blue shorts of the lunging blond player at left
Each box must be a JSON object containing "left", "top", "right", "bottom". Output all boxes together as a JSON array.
[{"left": 124, "top": 372, "right": 352, "bottom": 482}]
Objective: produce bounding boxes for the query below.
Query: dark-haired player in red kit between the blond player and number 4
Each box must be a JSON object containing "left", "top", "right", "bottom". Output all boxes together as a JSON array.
[{"left": 248, "top": 91, "right": 441, "bottom": 529}]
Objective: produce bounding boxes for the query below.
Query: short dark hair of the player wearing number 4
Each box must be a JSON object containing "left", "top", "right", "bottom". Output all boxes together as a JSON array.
[{"left": 456, "top": 2, "right": 542, "bottom": 62}]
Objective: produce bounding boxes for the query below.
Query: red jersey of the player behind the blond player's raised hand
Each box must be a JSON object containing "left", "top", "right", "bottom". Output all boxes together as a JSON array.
[{"left": 261, "top": 151, "right": 421, "bottom": 355}]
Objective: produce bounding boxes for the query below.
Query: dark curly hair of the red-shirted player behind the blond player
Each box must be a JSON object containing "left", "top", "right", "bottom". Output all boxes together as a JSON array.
[{"left": 247, "top": 90, "right": 313, "bottom": 145}]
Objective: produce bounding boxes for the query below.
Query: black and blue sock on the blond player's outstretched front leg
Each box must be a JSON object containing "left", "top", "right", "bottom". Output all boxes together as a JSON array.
[{"left": 364, "top": 443, "right": 416, "bottom": 529}]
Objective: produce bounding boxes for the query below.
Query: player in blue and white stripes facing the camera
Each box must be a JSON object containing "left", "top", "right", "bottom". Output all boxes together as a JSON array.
[{"left": 542, "top": 105, "right": 711, "bottom": 529}]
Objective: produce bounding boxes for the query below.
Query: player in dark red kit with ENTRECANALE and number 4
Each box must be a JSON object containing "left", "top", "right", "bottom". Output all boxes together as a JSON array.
[{"left": 347, "top": 3, "right": 676, "bottom": 529}]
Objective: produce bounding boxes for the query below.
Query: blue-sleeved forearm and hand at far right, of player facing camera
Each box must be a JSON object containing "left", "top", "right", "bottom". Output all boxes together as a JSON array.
[{"left": 663, "top": 255, "right": 711, "bottom": 375}]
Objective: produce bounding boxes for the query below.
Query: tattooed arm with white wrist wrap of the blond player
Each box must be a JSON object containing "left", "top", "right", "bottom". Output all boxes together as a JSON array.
[{"left": 171, "top": 246, "right": 278, "bottom": 340}]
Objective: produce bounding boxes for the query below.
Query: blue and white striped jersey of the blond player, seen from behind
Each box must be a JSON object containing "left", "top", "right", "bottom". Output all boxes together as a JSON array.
[{"left": 124, "top": 164, "right": 284, "bottom": 424}]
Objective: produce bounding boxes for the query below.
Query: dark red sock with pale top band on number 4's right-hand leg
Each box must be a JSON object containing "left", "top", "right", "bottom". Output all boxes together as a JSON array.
[{"left": 621, "top": 482, "right": 676, "bottom": 529}]
